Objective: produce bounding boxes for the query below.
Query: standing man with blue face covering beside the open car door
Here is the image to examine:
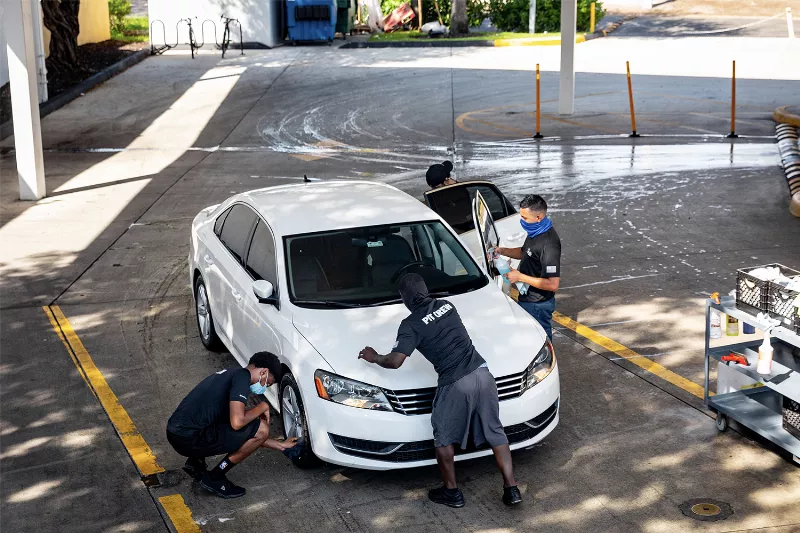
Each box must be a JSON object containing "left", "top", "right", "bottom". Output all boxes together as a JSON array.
[{"left": 496, "top": 194, "right": 561, "bottom": 339}]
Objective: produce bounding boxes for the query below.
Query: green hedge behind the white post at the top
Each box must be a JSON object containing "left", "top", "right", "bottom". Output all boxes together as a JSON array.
[{"left": 489, "top": 0, "right": 606, "bottom": 32}]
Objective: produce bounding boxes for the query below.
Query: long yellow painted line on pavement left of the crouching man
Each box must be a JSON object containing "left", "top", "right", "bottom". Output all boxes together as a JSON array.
[{"left": 42, "top": 305, "right": 164, "bottom": 476}]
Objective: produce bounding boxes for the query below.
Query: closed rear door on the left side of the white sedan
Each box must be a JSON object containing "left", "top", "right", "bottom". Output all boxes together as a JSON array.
[{"left": 209, "top": 204, "right": 257, "bottom": 357}]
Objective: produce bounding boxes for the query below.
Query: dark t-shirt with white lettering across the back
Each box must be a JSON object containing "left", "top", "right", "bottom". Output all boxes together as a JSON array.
[{"left": 392, "top": 300, "right": 486, "bottom": 386}]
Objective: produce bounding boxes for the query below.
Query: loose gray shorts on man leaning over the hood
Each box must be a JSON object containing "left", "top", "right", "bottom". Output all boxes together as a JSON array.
[{"left": 431, "top": 367, "right": 508, "bottom": 449}]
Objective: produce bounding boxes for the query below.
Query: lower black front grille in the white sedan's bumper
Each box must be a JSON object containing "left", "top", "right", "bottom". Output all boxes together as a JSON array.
[{"left": 328, "top": 400, "right": 558, "bottom": 463}]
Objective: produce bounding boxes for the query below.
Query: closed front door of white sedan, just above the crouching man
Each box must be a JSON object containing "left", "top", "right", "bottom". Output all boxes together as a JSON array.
[{"left": 239, "top": 218, "right": 283, "bottom": 405}]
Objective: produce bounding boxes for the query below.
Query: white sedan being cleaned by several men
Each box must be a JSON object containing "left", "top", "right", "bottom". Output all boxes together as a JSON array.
[{"left": 189, "top": 181, "right": 559, "bottom": 470}]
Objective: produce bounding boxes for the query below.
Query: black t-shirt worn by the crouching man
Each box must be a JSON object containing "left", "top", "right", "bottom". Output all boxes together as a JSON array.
[{"left": 167, "top": 367, "right": 250, "bottom": 437}]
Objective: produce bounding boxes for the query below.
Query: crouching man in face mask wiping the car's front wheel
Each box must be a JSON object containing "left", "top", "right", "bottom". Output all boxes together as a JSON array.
[{"left": 167, "top": 352, "right": 297, "bottom": 498}]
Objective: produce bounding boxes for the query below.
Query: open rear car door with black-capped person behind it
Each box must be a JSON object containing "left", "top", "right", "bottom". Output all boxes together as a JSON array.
[{"left": 424, "top": 181, "right": 525, "bottom": 259}]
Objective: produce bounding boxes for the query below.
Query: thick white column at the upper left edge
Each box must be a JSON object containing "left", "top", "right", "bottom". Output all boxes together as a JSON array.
[{"left": 2, "top": 0, "right": 45, "bottom": 200}]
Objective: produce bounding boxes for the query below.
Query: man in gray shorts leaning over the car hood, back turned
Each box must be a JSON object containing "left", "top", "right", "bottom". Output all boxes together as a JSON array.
[{"left": 358, "top": 274, "right": 522, "bottom": 507}]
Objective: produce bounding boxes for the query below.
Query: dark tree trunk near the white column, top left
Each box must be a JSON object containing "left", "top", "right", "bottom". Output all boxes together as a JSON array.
[{"left": 42, "top": 0, "right": 81, "bottom": 72}]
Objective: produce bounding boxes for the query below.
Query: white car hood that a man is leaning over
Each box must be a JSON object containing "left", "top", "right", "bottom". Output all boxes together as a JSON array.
[{"left": 293, "top": 284, "right": 545, "bottom": 390}]
